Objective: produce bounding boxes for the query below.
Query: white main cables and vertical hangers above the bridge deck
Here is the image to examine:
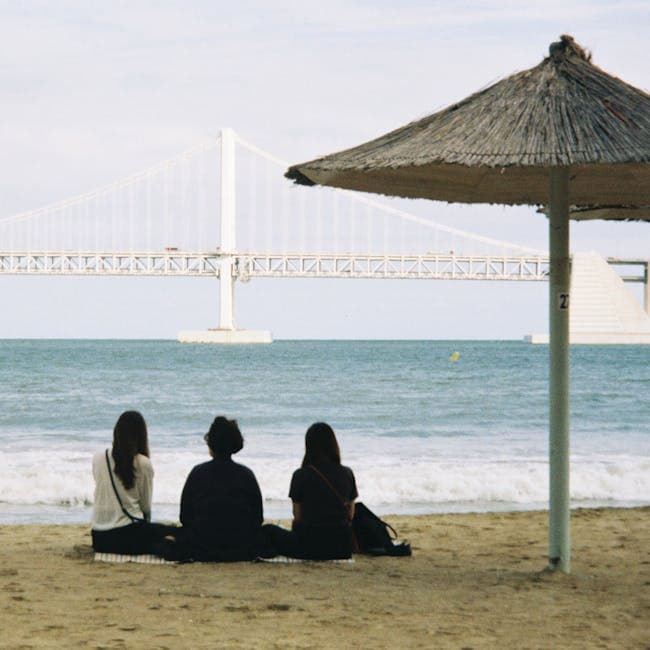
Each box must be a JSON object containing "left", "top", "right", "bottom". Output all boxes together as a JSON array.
[{"left": 0, "top": 132, "right": 546, "bottom": 259}]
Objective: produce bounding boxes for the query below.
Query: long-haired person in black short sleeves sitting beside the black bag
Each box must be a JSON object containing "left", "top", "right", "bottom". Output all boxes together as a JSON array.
[{"left": 262, "top": 422, "right": 358, "bottom": 560}]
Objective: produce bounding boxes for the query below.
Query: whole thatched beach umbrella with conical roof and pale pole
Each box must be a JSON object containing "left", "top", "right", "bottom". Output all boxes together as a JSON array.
[{"left": 286, "top": 36, "right": 650, "bottom": 572}]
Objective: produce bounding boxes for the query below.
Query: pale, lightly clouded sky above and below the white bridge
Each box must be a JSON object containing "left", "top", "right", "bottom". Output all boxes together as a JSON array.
[{"left": 0, "top": 0, "right": 650, "bottom": 339}]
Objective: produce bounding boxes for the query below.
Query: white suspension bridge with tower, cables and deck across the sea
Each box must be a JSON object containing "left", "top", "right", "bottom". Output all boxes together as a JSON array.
[{"left": 0, "top": 129, "right": 648, "bottom": 342}]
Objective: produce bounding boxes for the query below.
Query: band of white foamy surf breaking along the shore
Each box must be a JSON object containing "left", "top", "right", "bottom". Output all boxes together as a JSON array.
[{"left": 0, "top": 440, "right": 650, "bottom": 512}]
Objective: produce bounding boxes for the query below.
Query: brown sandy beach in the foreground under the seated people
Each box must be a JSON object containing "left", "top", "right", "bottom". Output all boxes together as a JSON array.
[{"left": 0, "top": 508, "right": 650, "bottom": 648}]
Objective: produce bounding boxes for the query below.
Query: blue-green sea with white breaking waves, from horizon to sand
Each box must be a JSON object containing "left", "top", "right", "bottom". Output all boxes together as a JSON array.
[{"left": 0, "top": 340, "right": 650, "bottom": 523}]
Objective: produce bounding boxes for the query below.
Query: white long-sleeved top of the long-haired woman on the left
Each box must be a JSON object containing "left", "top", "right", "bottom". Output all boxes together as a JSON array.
[{"left": 91, "top": 450, "right": 153, "bottom": 530}]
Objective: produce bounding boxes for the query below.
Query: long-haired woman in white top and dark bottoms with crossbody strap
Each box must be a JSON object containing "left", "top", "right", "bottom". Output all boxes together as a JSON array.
[{"left": 92, "top": 411, "right": 176, "bottom": 555}]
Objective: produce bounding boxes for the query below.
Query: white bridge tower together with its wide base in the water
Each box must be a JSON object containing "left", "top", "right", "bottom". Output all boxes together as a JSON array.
[{"left": 178, "top": 129, "right": 273, "bottom": 343}]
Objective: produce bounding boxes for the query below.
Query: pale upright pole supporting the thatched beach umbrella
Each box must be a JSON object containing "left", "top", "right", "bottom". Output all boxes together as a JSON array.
[{"left": 548, "top": 167, "right": 571, "bottom": 573}]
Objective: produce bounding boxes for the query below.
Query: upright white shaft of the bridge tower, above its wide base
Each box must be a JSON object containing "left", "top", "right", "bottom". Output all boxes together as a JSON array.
[{"left": 219, "top": 129, "right": 235, "bottom": 330}]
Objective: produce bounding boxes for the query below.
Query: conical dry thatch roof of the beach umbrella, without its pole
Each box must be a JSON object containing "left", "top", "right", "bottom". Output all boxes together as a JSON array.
[{"left": 286, "top": 36, "right": 650, "bottom": 213}]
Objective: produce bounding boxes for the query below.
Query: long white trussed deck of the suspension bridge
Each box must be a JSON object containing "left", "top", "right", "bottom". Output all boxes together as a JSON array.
[{"left": 0, "top": 251, "right": 549, "bottom": 281}]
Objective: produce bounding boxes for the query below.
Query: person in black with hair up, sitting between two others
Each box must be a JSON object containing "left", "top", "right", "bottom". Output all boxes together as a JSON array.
[{"left": 172, "top": 416, "right": 263, "bottom": 562}]
